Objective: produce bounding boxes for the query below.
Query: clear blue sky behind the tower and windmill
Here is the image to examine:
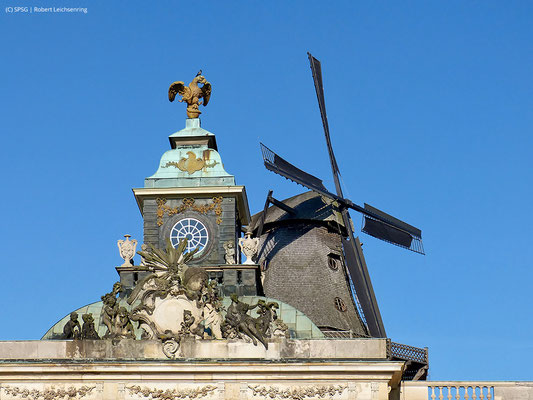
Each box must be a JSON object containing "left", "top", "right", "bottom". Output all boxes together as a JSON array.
[{"left": 0, "top": 0, "right": 533, "bottom": 380}]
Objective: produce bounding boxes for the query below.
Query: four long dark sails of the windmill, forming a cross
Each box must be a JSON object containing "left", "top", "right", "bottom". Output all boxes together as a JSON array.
[{"left": 259, "top": 53, "right": 424, "bottom": 337}]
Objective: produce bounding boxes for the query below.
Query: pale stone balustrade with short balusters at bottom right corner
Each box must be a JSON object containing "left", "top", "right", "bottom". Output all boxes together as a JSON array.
[{"left": 400, "top": 381, "right": 533, "bottom": 400}]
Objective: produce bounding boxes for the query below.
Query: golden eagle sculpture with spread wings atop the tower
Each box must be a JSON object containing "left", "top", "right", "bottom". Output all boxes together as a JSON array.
[{"left": 168, "top": 70, "right": 211, "bottom": 118}]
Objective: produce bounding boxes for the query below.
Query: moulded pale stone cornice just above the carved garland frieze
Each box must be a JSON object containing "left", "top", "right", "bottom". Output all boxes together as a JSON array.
[{"left": 0, "top": 361, "right": 404, "bottom": 384}]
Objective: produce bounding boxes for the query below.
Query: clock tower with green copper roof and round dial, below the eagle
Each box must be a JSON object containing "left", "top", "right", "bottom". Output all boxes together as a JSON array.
[{"left": 133, "top": 118, "right": 250, "bottom": 266}]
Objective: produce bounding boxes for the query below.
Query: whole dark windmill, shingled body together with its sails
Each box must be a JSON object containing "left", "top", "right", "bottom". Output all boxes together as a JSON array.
[{"left": 253, "top": 54, "right": 423, "bottom": 337}]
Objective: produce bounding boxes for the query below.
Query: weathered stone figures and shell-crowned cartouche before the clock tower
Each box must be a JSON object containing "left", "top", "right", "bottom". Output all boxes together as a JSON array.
[{"left": 62, "top": 237, "right": 289, "bottom": 358}]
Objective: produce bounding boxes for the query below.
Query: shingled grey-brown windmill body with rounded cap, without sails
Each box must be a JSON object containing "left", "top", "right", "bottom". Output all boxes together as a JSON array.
[{"left": 252, "top": 191, "right": 369, "bottom": 337}]
